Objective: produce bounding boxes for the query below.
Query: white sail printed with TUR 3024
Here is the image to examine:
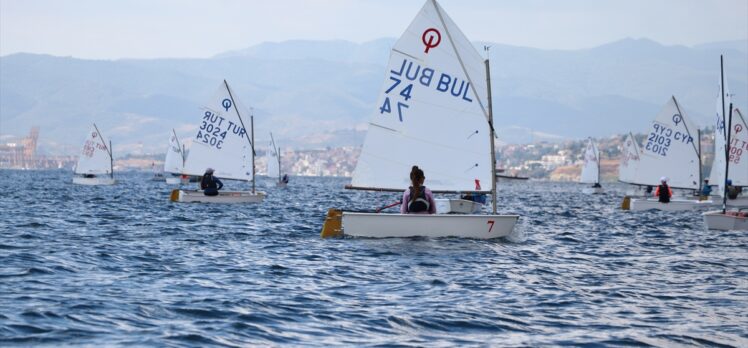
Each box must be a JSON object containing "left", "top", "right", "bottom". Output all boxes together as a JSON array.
[{"left": 182, "top": 82, "right": 253, "bottom": 181}]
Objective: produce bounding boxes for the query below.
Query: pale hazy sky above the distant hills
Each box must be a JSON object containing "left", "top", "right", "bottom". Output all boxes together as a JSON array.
[{"left": 0, "top": 0, "right": 748, "bottom": 59}]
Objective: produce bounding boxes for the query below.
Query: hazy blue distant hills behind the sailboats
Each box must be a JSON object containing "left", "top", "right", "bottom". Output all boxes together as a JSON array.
[{"left": 0, "top": 39, "right": 748, "bottom": 153}]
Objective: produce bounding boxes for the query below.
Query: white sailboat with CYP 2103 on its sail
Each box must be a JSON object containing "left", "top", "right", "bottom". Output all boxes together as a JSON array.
[{"left": 619, "top": 97, "right": 712, "bottom": 211}]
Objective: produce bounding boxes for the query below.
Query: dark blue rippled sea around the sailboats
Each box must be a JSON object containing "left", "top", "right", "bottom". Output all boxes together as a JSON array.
[{"left": 0, "top": 171, "right": 748, "bottom": 347}]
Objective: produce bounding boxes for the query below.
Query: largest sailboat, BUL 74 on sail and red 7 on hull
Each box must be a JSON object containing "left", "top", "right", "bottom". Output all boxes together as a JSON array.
[{"left": 322, "top": 0, "right": 519, "bottom": 239}]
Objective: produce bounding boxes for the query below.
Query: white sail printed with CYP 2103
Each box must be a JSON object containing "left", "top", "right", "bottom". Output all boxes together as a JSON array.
[{"left": 630, "top": 97, "right": 701, "bottom": 189}]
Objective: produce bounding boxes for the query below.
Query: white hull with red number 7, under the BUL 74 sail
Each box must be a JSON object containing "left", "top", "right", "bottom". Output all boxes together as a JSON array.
[{"left": 343, "top": 212, "right": 519, "bottom": 239}]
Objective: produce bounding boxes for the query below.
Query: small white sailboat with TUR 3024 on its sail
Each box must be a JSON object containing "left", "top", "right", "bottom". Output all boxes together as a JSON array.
[{"left": 171, "top": 80, "right": 265, "bottom": 203}]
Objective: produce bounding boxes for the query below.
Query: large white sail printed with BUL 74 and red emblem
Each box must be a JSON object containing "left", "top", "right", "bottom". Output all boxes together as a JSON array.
[{"left": 352, "top": 0, "right": 493, "bottom": 191}]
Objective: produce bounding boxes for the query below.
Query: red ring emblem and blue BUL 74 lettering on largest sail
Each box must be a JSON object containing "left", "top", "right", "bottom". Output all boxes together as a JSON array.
[{"left": 379, "top": 28, "right": 473, "bottom": 122}]
